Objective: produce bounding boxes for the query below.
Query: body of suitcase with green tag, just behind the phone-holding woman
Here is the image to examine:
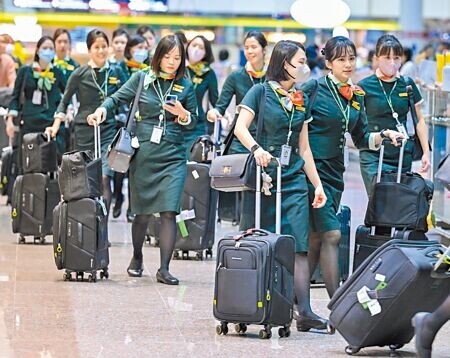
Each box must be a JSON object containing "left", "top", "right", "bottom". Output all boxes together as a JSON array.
[{"left": 174, "top": 162, "right": 218, "bottom": 260}]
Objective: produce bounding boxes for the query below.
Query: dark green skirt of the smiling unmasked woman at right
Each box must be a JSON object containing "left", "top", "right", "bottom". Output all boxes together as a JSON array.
[{"left": 308, "top": 156, "right": 345, "bottom": 232}]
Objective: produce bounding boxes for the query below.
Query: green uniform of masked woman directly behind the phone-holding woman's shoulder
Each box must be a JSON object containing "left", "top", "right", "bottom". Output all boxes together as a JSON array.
[{"left": 183, "top": 66, "right": 219, "bottom": 154}]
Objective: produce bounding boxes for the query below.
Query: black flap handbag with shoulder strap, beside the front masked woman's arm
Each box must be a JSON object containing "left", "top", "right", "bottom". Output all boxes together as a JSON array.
[{"left": 209, "top": 84, "right": 266, "bottom": 192}]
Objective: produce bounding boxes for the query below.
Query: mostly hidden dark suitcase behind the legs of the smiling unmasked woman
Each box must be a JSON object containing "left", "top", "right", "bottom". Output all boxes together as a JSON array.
[{"left": 311, "top": 205, "right": 351, "bottom": 284}]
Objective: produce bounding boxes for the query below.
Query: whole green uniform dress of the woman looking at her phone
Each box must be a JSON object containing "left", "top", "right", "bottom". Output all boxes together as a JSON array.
[{"left": 102, "top": 70, "right": 197, "bottom": 215}]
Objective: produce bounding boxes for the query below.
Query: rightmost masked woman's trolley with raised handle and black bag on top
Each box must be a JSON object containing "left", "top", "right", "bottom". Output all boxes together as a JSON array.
[{"left": 353, "top": 139, "right": 434, "bottom": 269}]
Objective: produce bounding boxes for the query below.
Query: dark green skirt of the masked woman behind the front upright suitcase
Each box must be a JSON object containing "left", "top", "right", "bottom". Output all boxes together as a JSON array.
[{"left": 240, "top": 158, "right": 310, "bottom": 252}]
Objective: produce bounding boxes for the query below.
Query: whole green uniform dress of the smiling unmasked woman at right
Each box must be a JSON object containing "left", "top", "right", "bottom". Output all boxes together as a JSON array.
[{"left": 302, "top": 76, "right": 370, "bottom": 232}]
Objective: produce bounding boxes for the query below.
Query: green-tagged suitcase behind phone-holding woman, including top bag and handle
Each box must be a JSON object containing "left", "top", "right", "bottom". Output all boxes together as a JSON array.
[{"left": 174, "top": 117, "right": 220, "bottom": 260}]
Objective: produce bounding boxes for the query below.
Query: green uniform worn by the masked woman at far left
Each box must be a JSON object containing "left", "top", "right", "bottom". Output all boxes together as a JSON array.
[{"left": 9, "top": 62, "right": 66, "bottom": 154}]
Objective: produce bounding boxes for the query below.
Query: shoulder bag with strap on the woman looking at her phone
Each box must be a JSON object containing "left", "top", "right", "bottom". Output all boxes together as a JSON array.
[{"left": 106, "top": 72, "right": 145, "bottom": 173}]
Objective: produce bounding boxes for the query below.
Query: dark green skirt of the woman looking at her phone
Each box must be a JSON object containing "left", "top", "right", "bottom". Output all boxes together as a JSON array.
[{"left": 129, "top": 139, "right": 186, "bottom": 214}]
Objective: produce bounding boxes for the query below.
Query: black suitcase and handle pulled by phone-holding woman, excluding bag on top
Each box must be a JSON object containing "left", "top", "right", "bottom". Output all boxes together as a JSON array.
[{"left": 53, "top": 126, "right": 109, "bottom": 282}]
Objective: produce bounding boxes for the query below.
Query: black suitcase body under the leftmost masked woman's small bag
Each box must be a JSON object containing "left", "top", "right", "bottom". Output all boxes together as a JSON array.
[{"left": 11, "top": 173, "right": 60, "bottom": 243}]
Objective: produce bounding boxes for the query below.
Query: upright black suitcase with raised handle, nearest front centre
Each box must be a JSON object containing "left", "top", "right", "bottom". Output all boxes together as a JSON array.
[{"left": 213, "top": 159, "right": 295, "bottom": 339}]
